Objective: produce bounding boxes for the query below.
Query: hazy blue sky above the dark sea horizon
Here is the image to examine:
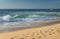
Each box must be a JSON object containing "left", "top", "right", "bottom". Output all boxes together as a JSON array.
[{"left": 0, "top": 0, "right": 60, "bottom": 9}]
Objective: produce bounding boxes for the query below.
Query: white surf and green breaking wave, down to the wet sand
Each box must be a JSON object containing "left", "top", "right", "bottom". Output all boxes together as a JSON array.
[{"left": 0, "top": 13, "right": 60, "bottom": 26}]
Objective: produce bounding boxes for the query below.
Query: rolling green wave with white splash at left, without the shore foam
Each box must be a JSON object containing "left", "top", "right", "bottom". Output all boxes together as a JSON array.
[{"left": 0, "top": 14, "right": 60, "bottom": 22}]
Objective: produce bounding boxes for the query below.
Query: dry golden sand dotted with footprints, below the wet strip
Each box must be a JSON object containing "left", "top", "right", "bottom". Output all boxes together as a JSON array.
[{"left": 0, "top": 23, "right": 60, "bottom": 39}]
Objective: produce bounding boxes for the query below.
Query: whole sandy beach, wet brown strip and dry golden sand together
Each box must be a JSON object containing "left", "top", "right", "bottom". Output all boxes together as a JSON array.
[{"left": 0, "top": 19, "right": 60, "bottom": 39}]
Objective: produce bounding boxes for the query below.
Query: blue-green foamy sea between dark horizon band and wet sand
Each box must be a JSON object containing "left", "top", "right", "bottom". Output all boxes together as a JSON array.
[{"left": 0, "top": 10, "right": 60, "bottom": 27}]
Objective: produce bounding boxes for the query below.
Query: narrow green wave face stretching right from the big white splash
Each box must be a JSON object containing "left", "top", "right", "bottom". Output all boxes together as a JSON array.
[{"left": 14, "top": 14, "right": 60, "bottom": 18}]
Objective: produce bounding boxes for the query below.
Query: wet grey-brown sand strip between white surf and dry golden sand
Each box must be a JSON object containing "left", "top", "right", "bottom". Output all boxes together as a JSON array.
[{"left": 0, "top": 19, "right": 60, "bottom": 33}]
